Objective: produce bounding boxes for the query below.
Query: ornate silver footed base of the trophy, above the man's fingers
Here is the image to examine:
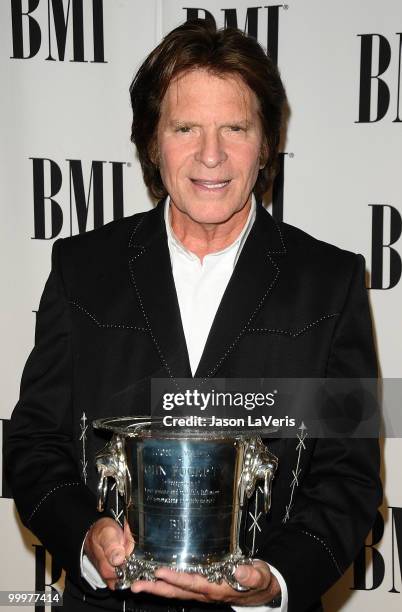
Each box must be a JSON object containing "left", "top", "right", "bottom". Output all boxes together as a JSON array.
[{"left": 116, "top": 553, "right": 253, "bottom": 592}]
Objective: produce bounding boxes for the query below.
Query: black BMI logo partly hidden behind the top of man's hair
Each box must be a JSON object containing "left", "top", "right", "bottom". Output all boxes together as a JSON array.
[{"left": 183, "top": 4, "right": 287, "bottom": 63}]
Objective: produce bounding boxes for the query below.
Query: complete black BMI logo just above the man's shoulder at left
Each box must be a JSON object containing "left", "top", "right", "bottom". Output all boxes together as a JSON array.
[{"left": 30, "top": 157, "right": 126, "bottom": 240}]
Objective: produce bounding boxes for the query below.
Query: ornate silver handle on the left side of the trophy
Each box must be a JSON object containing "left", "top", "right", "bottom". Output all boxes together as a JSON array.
[{"left": 96, "top": 434, "right": 131, "bottom": 512}]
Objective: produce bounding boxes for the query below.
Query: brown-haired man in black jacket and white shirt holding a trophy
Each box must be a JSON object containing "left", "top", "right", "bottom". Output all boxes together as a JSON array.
[{"left": 7, "top": 21, "right": 381, "bottom": 612}]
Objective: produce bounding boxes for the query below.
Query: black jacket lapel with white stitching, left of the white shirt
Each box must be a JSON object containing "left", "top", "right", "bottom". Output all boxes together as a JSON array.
[{"left": 129, "top": 202, "right": 191, "bottom": 378}]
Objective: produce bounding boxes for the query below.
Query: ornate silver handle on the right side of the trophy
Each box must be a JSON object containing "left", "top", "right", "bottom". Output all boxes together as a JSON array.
[{"left": 238, "top": 438, "right": 278, "bottom": 513}]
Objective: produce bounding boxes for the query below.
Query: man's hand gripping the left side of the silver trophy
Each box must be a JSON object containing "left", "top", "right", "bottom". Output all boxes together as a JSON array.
[{"left": 84, "top": 517, "right": 134, "bottom": 589}]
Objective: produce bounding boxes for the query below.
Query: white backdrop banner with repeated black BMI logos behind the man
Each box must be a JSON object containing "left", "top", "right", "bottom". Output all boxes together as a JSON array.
[{"left": 0, "top": 0, "right": 402, "bottom": 612}]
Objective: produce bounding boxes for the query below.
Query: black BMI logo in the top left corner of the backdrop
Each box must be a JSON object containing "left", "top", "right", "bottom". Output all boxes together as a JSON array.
[{"left": 11, "top": 0, "right": 105, "bottom": 63}]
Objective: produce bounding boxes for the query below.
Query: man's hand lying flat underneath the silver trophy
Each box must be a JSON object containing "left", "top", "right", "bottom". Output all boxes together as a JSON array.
[{"left": 131, "top": 561, "right": 280, "bottom": 606}]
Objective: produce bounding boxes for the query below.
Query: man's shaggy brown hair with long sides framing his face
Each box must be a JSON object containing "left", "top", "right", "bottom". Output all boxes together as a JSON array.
[{"left": 130, "top": 19, "right": 286, "bottom": 199}]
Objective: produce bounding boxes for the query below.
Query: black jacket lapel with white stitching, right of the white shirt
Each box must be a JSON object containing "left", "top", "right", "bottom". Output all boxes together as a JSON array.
[{"left": 195, "top": 205, "right": 286, "bottom": 378}]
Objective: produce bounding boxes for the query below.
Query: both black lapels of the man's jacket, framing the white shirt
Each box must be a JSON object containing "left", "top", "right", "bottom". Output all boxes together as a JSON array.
[{"left": 129, "top": 201, "right": 286, "bottom": 378}]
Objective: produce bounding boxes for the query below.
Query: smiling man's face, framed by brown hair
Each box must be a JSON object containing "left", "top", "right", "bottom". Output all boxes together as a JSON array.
[{"left": 157, "top": 69, "right": 264, "bottom": 224}]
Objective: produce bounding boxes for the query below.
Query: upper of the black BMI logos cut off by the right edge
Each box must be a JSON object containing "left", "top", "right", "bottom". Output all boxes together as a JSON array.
[{"left": 356, "top": 33, "right": 402, "bottom": 123}]
